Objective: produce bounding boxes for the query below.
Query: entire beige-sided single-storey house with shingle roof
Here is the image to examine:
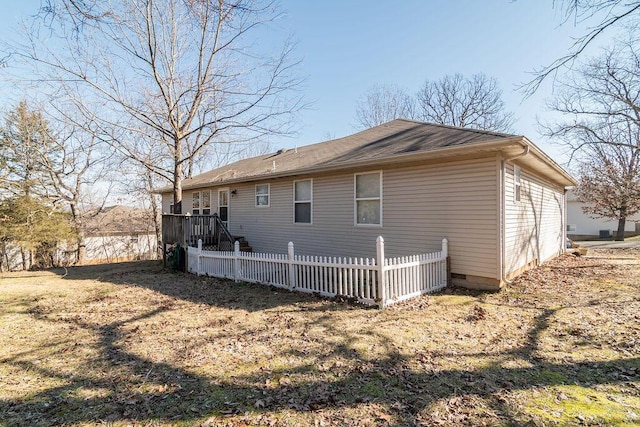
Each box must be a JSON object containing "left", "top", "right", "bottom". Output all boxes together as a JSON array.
[{"left": 159, "top": 120, "right": 576, "bottom": 289}]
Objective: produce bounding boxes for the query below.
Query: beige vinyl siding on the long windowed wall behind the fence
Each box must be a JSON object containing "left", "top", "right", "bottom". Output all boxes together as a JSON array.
[{"left": 194, "top": 156, "right": 499, "bottom": 278}]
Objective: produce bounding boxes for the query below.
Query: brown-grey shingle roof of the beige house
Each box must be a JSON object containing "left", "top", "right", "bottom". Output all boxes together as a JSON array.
[{"left": 171, "top": 119, "right": 515, "bottom": 192}]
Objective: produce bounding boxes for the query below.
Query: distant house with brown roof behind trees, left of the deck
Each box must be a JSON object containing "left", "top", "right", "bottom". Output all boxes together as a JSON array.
[{"left": 59, "top": 205, "right": 158, "bottom": 264}]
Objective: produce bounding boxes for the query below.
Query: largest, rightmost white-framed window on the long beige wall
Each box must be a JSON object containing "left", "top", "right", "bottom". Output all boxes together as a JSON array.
[{"left": 354, "top": 172, "right": 382, "bottom": 225}]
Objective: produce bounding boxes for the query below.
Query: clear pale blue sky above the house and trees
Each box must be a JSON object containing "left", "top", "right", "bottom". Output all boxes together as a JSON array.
[{"left": 0, "top": 0, "right": 606, "bottom": 167}]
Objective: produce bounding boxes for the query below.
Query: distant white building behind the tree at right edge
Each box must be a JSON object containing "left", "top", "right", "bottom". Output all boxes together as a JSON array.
[{"left": 567, "top": 190, "right": 640, "bottom": 240}]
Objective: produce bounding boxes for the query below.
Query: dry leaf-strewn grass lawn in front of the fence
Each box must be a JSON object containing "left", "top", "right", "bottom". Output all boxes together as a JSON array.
[{"left": 0, "top": 250, "right": 640, "bottom": 426}]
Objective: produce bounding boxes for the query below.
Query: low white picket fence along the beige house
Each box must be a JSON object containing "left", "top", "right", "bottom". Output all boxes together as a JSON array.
[{"left": 187, "top": 236, "right": 448, "bottom": 308}]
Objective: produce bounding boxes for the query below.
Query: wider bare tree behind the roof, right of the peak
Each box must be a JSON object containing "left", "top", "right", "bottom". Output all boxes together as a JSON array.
[{"left": 416, "top": 73, "right": 514, "bottom": 132}]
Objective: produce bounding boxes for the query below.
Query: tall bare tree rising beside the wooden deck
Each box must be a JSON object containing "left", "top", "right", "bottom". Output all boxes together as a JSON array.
[{"left": 13, "top": 0, "right": 302, "bottom": 213}]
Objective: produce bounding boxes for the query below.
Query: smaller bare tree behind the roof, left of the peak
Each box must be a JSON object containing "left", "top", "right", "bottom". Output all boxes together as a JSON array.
[{"left": 356, "top": 84, "right": 415, "bottom": 128}]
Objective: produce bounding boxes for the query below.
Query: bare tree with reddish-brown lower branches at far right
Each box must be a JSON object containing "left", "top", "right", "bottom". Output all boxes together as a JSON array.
[{"left": 543, "top": 38, "right": 640, "bottom": 240}]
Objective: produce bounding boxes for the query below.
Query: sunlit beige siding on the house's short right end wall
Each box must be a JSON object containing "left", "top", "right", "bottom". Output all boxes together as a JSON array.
[{"left": 504, "top": 164, "right": 564, "bottom": 275}]
